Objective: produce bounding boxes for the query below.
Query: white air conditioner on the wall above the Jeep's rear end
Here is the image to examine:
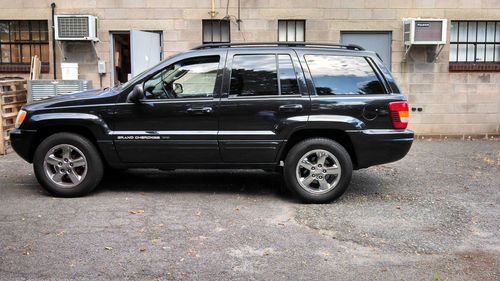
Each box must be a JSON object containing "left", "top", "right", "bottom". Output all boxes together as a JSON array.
[{"left": 403, "top": 19, "right": 447, "bottom": 46}]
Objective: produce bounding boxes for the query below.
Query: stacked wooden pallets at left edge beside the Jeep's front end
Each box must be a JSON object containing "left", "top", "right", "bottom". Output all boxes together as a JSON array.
[{"left": 0, "top": 79, "right": 27, "bottom": 155}]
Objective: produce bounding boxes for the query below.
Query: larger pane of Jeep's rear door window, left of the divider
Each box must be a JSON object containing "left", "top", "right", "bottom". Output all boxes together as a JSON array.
[{"left": 230, "top": 55, "right": 278, "bottom": 96}]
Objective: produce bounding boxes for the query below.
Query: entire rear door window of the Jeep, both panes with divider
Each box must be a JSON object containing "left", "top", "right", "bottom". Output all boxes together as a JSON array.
[{"left": 230, "top": 55, "right": 299, "bottom": 96}]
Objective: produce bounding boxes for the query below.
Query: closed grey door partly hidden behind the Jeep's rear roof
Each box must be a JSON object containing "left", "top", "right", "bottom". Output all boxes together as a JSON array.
[{"left": 340, "top": 31, "right": 392, "bottom": 69}]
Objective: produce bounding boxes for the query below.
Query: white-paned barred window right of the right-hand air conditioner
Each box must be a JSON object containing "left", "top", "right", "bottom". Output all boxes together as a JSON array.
[{"left": 450, "top": 21, "right": 500, "bottom": 63}]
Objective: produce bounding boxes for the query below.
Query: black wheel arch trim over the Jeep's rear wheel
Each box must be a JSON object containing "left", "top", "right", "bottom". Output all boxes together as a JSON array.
[{"left": 278, "top": 129, "right": 358, "bottom": 169}]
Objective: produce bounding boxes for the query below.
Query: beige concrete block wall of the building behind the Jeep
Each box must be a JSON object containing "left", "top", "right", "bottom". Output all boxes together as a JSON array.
[{"left": 0, "top": 0, "right": 500, "bottom": 135}]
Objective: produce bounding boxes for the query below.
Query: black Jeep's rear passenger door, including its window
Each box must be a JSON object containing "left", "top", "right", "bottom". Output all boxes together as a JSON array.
[{"left": 219, "top": 48, "right": 309, "bottom": 163}]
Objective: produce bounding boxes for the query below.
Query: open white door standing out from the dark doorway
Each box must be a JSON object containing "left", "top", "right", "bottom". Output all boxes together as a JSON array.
[{"left": 130, "top": 30, "right": 161, "bottom": 77}]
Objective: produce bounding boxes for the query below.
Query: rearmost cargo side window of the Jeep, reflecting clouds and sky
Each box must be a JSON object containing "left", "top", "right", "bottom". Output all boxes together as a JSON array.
[{"left": 305, "top": 55, "right": 385, "bottom": 95}]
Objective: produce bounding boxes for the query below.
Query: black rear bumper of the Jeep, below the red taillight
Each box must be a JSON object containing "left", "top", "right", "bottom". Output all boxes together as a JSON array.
[{"left": 348, "top": 129, "right": 414, "bottom": 169}]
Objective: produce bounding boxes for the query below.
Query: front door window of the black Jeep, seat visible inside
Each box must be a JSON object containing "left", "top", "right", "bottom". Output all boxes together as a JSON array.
[{"left": 144, "top": 56, "right": 219, "bottom": 99}]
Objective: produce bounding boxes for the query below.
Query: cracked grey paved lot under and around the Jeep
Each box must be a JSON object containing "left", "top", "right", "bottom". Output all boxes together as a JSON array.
[{"left": 0, "top": 140, "right": 500, "bottom": 280}]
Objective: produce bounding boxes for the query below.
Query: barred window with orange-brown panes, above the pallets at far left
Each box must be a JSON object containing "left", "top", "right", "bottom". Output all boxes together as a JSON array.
[{"left": 0, "top": 20, "right": 49, "bottom": 65}]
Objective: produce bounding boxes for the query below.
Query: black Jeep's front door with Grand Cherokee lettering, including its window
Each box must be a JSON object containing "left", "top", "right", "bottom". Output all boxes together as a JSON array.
[{"left": 113, "top": 54, "right": 225, "bottom": 164}]
